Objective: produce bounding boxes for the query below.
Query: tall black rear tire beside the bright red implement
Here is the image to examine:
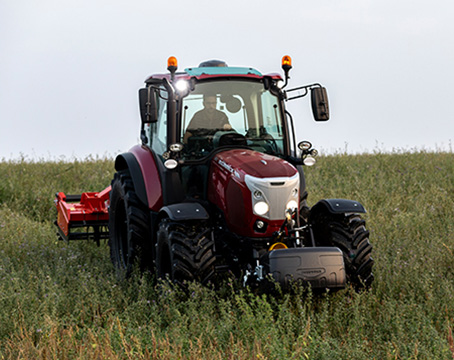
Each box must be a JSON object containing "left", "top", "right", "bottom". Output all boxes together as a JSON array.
[{"left": 109, "top": 170, "right": 151, "bottom": 276}]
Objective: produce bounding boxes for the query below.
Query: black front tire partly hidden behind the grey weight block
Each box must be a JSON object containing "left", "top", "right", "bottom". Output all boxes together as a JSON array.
[{"left": 312, "top": 214, "right": 374, "bottom": 289}]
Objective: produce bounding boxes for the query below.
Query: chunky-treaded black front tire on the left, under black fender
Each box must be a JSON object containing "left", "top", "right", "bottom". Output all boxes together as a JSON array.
[{"left": 156, "top": 219, "right": 216, "bottom": 285}]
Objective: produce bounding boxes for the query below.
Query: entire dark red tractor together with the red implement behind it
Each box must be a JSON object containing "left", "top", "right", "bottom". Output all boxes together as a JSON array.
[{"left": 55, "top": 56, "right": 373, "bottom": 290}]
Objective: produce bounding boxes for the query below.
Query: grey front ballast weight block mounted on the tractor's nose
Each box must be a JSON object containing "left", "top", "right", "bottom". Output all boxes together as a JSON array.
[{"left": 268, "top": 247, "right": 346, "bottom": 289}]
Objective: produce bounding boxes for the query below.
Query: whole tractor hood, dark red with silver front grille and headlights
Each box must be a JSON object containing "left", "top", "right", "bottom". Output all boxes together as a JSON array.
[{"left": 207, "top": 149, "right": 300, "bottom": 237}]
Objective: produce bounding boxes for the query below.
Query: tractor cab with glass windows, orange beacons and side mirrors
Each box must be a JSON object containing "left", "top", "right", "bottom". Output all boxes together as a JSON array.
[{"left": 139, "top": 57, "right": 328, "bottom": 199}]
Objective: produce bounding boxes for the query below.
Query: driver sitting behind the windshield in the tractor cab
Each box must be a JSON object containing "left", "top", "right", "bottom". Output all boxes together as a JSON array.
[{"left": 183, "top": 94, "right": 232, "bottom": 143}]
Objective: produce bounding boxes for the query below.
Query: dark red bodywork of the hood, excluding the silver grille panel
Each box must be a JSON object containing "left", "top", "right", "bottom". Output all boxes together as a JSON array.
[{"left": 207, "top": 149, "right": 297, "bottom": 237}]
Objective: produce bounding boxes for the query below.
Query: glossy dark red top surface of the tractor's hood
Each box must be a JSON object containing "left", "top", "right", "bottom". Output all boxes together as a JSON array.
[{"left": 214, "top": 149, "right": 298, "bottom": 180}]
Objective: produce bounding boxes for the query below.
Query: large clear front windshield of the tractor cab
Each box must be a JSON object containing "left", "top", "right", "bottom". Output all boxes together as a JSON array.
[{"left": 180, "top": 80, "right": 284, "bottom": 159}]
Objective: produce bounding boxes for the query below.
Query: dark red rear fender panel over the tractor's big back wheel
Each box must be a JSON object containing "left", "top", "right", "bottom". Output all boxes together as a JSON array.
[{"left": 129, "top": 145, "right": 163, "bottom": 212}]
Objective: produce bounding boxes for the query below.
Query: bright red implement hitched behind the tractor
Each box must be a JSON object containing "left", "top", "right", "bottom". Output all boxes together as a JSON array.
[{"left": 54, "top": 186, "right": 111, "bottom": 242}]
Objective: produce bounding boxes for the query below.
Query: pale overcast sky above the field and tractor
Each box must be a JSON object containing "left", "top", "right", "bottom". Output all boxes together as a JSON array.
[{"left": 0, "top": 0, "right": 454, "bottom": 160}]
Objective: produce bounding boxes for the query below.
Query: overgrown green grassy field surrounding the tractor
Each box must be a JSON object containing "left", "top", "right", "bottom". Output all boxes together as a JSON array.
[{"left": 0, "top": 152, "right": 454, "bottom": 359}]
